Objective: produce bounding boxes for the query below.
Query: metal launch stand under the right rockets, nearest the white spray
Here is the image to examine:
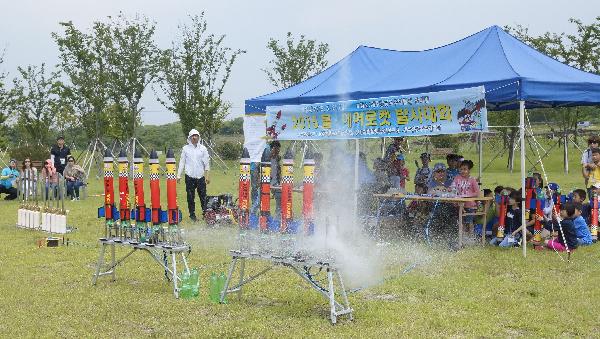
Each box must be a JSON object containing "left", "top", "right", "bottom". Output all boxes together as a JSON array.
[{"left": 220, "top": 250, "right": 354, "bottom": 324}]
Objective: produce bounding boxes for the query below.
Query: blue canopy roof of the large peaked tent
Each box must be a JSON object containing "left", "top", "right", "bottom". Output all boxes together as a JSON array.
[{"left": 246, "top": 26, "right": 600, "bottom": 114}]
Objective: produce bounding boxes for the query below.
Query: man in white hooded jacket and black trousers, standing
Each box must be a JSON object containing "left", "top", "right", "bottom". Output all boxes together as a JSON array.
[{"left": 177, "top": 129, "right": 210, "bottom": 221}]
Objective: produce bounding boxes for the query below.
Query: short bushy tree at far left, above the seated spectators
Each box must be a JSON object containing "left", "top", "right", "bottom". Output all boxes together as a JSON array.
[{"left": 12, "top": 63, "right": 63, "bottom": 143}]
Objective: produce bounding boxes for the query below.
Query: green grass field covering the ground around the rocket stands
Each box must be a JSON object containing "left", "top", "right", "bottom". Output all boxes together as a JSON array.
[{"left": 0, "top": 139, "right": 600, "bottom": 338}]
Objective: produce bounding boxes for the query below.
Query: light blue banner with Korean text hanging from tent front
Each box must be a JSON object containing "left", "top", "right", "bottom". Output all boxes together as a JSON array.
[{"left": 267, "top": 86, "right": 488, "bottom": 140}]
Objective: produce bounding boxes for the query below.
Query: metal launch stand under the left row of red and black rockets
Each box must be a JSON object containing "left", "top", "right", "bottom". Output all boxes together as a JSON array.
[{"left": 92, "top": 238, "right": 191, "bottom": 298}]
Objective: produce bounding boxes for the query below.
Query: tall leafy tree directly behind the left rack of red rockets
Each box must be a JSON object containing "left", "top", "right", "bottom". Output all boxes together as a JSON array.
[{"left": 94, "top": 13, "right": 165, "bottom": 139}]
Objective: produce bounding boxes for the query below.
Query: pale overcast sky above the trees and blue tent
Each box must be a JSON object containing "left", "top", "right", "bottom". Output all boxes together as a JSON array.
[{"left": 0, "top": 0, "right": 600, "bottom": 125}]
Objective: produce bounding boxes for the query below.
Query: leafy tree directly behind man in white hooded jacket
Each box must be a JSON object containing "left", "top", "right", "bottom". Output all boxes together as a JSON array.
[{"left": 157, "top": 13, "right": 245, "bottom": 140}]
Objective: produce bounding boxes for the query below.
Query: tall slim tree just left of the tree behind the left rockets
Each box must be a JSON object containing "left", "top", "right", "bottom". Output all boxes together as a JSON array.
[{"left": 52, "top": 21, "right": 109, "bottom": 139}]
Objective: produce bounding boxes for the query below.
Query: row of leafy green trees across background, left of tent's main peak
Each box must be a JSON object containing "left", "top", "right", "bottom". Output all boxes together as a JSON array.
[{"left": 0, "top": 13, "right": 328, "bottom": 148}]
